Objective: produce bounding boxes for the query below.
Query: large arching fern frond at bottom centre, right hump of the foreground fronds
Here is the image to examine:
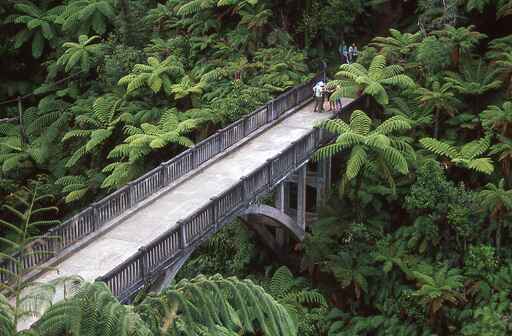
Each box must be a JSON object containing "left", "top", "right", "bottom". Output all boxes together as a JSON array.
[{"left": 137, "top": 275, "right": 297, "bottom": 335}]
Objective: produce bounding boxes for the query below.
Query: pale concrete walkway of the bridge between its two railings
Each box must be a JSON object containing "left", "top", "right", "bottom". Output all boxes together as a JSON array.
[{"left": 35, "top": 99, "right": 349, "bottom": 282}]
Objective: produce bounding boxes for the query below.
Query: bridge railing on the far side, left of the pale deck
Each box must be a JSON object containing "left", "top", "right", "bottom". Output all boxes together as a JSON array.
[{"left": 0, "top": 76, "right": 318, "bottom": 283}]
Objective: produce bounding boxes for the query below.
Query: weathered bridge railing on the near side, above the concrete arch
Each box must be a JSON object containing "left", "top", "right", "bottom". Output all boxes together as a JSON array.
[{"left": 97, "top": 95, "right": 362, "bottom": 301}]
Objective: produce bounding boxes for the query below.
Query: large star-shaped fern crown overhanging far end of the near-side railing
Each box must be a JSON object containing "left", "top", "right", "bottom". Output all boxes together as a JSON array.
[{"left": 315, "top": 110, "right": 415, "bottom": 193}]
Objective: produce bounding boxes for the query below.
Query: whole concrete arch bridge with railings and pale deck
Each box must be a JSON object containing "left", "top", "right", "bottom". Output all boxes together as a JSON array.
[{"left": 0, "top": 77, "right": 358, "bottom": 312}]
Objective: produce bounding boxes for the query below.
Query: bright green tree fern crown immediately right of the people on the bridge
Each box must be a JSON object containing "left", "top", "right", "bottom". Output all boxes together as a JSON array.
[{"left": 331, "top": 55, "right": 415, "bottom": 105}]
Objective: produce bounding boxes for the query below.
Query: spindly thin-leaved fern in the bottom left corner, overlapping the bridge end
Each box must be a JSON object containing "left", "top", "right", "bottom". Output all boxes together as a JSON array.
[{"left": 0, "top": 183, "right": 80, "bottom": 336}]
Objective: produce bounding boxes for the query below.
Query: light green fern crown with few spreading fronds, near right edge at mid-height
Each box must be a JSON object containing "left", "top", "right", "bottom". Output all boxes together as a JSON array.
[{"left": 420, "top": 137, "right": 494, "bottom": 174}]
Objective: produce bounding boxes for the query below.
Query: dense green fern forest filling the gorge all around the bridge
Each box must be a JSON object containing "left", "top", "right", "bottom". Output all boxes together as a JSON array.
[{"left": 0, "top": 0, "right": 512, "bottom": 336}]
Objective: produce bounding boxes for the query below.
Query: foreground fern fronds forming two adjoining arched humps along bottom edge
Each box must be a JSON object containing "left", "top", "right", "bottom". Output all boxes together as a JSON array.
[{"left": 33, "top": 275, "right": 297, "bottom": 336}]
